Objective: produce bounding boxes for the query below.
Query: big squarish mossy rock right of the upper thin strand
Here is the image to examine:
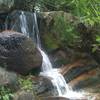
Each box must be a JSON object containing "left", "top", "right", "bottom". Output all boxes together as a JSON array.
[{"left": 39, "top": 11, "right": 79, "bottom": 51}]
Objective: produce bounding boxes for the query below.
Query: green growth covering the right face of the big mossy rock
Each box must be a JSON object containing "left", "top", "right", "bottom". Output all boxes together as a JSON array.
[{"left": 54, "top": 16, "right": 78, "bottom": 45}]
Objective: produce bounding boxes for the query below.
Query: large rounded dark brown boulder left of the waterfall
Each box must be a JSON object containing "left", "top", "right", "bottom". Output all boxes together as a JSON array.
[{"left": 0, "top": 31, "right": 42, "bottom": 74}]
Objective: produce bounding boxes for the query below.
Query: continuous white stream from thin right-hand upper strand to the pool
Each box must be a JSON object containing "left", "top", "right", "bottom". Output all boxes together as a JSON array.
[{"left": 34, "top": 13, "right": 82, "bottom": 98}]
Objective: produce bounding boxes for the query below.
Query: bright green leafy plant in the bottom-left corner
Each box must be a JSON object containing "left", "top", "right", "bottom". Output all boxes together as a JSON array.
[{"left": 0, "top": 86, "right": 13, "bottom": 100}]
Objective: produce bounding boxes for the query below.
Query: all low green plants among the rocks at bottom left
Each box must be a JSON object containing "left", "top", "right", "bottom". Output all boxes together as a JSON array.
[{"left": 0, "top": 75, "right": 39, "bottom": 100}]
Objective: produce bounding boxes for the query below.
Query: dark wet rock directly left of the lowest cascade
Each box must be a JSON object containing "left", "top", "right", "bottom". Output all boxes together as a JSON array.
[{"left": 33, "top": 76, "right": 58, "bottom": 97}]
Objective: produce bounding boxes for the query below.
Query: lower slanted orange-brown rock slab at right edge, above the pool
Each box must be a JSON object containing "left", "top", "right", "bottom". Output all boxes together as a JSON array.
[{"left": 70, "top": 68, "right": 100, "bottom": 90}]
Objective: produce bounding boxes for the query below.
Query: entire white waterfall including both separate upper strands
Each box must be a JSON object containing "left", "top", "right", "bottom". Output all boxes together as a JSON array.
[{"left": 20, "top": 12, "right": 82, "bottom": 98}]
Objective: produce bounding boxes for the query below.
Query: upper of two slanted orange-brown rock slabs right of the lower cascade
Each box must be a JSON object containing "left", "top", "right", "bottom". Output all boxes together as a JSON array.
[{"left": 58, "top": 52, "right": 99, "bottom": 83}]
